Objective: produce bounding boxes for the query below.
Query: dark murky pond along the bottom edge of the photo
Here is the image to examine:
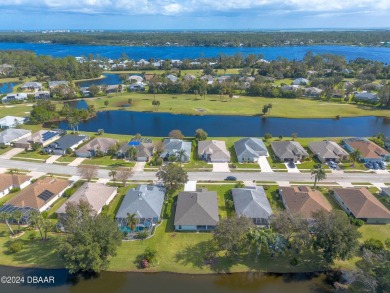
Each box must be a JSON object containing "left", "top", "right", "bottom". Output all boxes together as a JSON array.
[{"left": 0, "top": 267, "right": 331, "bottom": 293}]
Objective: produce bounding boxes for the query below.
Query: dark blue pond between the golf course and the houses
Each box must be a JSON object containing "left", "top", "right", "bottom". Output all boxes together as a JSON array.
[{"left": 59, "top": 105, "right": 390, "bottom": 137}]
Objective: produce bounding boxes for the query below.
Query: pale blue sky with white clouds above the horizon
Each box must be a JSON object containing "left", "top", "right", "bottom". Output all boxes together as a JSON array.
[{"left": 0, "top": 0, "right": 390, "bottom": 30}]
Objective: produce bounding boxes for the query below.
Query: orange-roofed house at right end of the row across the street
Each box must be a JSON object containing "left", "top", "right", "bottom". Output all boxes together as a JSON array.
[{"left": 343, "top": 137, "right": 390, "bottom": 163}]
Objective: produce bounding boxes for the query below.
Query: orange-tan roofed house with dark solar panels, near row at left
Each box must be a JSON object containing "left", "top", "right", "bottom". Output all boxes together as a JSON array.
[{"left": 0, "top": 177, "right": 73, "bottom": 221}]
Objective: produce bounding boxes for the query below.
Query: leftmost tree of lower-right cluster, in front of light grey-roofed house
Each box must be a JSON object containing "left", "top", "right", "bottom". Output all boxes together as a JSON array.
[{"left": 213, "top": 217, "right": 254, "bottom": 257}]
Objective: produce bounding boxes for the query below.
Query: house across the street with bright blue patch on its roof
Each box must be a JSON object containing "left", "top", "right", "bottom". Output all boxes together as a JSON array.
[{"left": 116, "top": 138, "right": 154, "bottom": 162}]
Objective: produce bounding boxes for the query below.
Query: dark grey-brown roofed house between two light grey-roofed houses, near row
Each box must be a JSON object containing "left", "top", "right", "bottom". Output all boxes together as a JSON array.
[{"left": 174, "top": 188, "right": 219, "bottom": 231}]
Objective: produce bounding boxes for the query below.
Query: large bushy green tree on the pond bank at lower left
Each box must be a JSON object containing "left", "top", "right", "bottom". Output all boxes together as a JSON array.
[{"left": 58, "top": 201, "right": 122, "bottom": 273}]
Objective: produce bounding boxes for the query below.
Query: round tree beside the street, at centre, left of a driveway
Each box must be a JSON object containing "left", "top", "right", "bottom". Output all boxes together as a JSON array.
[{"left": 156, "top": 164, "right": 188, "bottom": 191}]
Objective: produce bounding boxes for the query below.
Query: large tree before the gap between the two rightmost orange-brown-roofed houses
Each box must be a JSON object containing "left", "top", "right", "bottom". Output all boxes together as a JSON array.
[{"left": 313, "top": 210, "right": 360, "bottom": 263}]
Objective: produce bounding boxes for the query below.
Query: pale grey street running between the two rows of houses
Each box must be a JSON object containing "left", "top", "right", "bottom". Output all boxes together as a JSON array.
[{"left": 0, "top": 159, "right": 390, "bottom": 183}]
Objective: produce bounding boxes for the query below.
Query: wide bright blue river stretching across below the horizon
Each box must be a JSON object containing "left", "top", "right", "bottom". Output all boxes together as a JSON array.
[{"left": 0, "top": 43, "right": 390, "bottom": 63}]
